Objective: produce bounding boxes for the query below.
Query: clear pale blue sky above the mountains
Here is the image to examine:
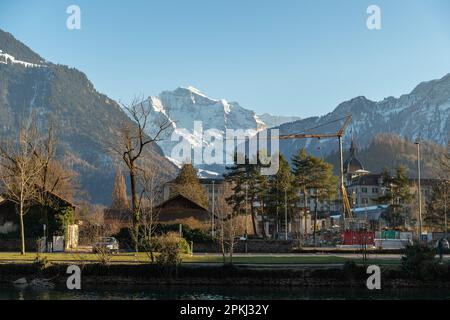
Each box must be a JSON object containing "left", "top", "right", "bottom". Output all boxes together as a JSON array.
[{"left": 0, "top": 0, "right": 450, "bottom": 117}]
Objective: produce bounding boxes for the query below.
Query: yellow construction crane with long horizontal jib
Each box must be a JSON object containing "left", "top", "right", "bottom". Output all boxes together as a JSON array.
[{"left": 279, "top": 116, "right": 353, "bottom": 228}]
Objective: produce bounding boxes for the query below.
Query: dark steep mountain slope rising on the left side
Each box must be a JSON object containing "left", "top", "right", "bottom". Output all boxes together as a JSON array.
[{"left": 0, "top": 30, "right": 177, "bottom": 205}]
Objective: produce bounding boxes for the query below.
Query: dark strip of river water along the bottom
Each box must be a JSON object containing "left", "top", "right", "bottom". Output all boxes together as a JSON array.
[{"left": 0, "top": 285, "right": 450, "bottom": 300}]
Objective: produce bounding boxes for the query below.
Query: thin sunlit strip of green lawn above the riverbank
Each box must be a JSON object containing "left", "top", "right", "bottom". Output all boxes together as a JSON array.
[{"left": 0, "top": 253, "right": 400, "bottom": 265}]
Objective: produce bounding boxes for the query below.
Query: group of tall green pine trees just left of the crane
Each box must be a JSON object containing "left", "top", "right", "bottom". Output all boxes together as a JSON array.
[{"left": 225, "top": 149, "right": 338, "bottom": 236}]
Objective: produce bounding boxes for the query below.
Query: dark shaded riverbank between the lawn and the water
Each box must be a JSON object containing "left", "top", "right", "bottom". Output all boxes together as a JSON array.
[{"left": 0, "top": 263, "right": 450, "bottom": 288}]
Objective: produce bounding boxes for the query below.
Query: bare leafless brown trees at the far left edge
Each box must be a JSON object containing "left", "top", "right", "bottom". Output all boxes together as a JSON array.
[{"left": 0, "top": 115, "right": 76, "bottom": 254}]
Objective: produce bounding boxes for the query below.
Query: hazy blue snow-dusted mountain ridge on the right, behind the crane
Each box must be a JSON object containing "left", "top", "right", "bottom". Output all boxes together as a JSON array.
[{"left": 279, "top": 74, "right": 450, "bottom": 159}]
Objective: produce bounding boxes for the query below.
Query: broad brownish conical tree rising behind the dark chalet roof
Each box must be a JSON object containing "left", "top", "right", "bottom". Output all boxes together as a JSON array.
[{"left": 171, "top": 163, "right": 208, "bottom": 208}]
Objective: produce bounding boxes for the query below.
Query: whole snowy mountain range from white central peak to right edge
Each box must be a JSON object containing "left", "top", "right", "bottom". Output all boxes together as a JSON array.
[{"left": 145, "top": 74, "right": 450, "bottom": 174}]
